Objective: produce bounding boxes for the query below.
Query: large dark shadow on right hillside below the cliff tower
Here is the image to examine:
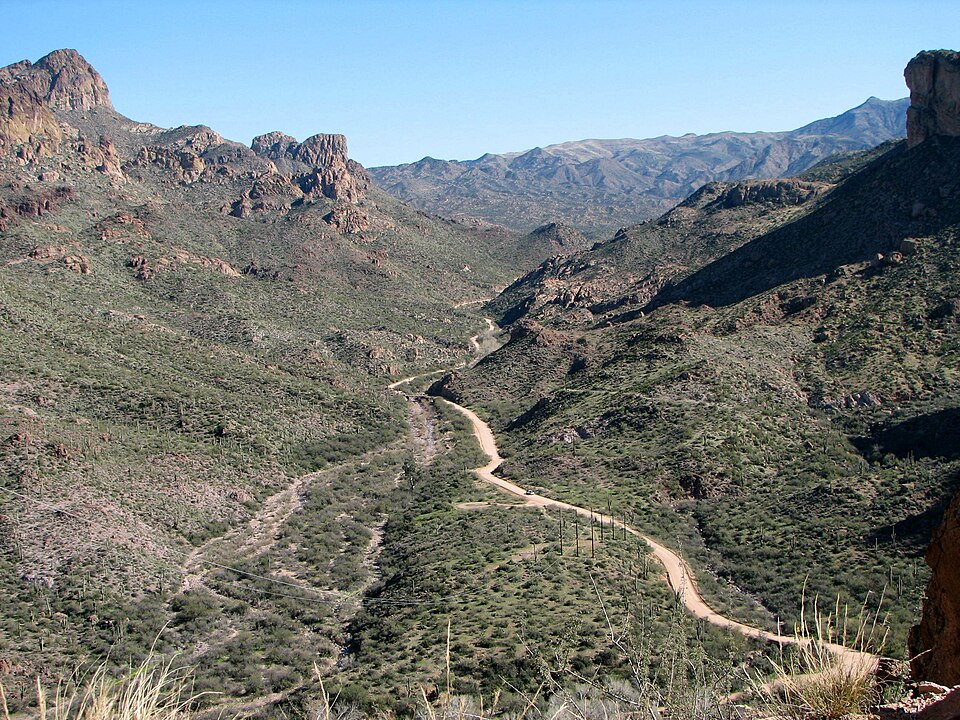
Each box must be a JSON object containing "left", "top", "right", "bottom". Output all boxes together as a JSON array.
[{"left": 643, "top": 137, "right": 960, "bottom": 313}]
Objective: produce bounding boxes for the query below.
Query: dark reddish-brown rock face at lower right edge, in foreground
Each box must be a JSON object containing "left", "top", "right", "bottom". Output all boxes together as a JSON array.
[{"left": 910, "top": 493, "right": 960, "bottom": 686}]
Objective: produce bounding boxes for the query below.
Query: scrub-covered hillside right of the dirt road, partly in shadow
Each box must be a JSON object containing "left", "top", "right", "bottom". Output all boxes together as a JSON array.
[{"left": 433, "top": 50, "right": 960, "bottom": 656}]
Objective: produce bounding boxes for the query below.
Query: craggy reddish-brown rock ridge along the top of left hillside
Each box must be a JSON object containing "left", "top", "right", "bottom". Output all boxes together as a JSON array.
[{"left": 0, "top": 50, "right": 370, "bottom": 221}]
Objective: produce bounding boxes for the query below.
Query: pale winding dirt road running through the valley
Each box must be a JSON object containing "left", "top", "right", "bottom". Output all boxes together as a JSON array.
[{"left": 388, "top": 318, "right": 878, "bottom": 667}]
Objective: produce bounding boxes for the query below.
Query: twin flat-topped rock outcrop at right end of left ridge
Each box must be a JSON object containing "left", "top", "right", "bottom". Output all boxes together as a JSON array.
[{"left": 250, "top": 132, "right": 370, "bottom": 202}]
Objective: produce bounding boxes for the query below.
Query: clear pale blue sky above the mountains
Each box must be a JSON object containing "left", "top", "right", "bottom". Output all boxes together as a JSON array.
[{"left": 0, "top": 0, "right": 960, "bottom": 166}]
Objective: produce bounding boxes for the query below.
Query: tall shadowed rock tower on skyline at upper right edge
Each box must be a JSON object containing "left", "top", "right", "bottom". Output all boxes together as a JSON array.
[{"left": 903, "top": 50, "right": 960, "bottom": 147}]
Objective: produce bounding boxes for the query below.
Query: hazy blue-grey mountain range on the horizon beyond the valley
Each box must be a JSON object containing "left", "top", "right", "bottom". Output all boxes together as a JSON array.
[{"left": 369, "top": 97, "right": 910, "bottom": 234}]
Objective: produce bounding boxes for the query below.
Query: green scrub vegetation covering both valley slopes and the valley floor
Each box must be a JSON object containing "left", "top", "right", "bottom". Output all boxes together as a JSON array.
[{"left": 0, "top": 45, "right": 960, "bottom": 720}]
